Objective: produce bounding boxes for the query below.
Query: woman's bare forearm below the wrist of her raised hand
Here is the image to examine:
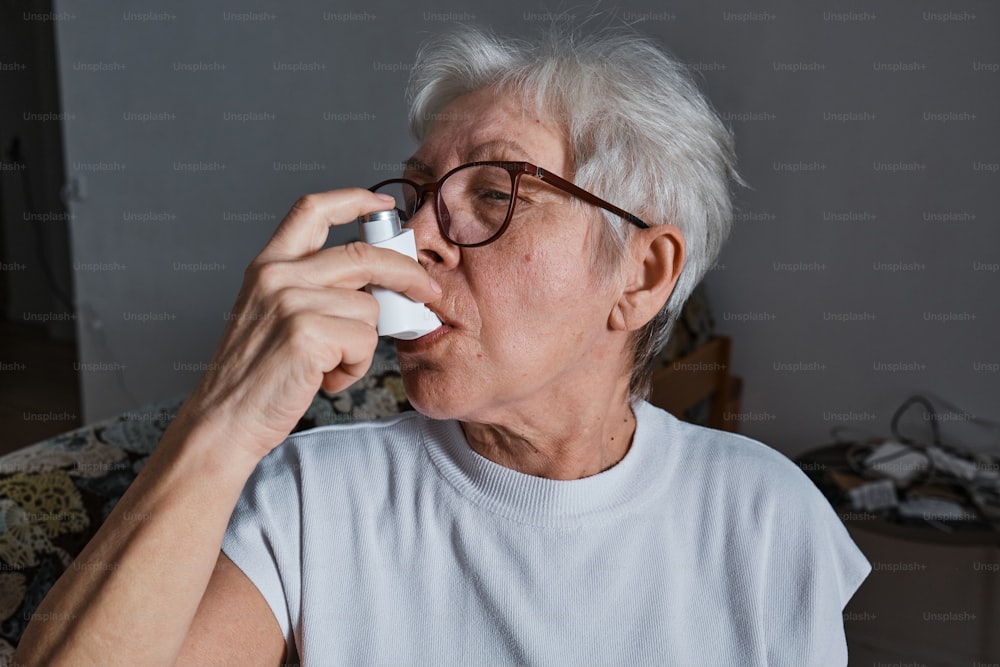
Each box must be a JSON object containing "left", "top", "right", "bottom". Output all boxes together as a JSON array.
[{"left": 14, "top": 415, "right": 256, "bottom": 665}]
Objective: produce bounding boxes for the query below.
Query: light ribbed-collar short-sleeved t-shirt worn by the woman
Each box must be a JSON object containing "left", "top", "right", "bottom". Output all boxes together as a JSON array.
[{"left": 223, "top": 403, "right": 871, "bottom": 667}]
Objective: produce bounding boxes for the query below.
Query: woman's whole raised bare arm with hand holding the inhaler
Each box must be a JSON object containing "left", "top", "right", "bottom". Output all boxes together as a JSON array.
[{"left": 13, "top": 189, "right": 440, "bottom": 667}]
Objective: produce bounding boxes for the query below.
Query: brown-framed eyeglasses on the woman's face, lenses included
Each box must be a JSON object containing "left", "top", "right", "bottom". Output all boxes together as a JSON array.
[{"left": 369, "top": 162, "right": 649, "bottom": 248}]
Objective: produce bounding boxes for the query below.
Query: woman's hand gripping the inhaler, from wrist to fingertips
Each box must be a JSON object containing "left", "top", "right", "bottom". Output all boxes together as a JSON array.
[{"left": 187, "top": 188, "right": 441, "bottom": 455}]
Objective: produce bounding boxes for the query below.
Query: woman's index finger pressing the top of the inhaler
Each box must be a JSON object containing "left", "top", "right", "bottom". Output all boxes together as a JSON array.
[{"left": 255, "top": 188, "right": 395, "bottom": 263}]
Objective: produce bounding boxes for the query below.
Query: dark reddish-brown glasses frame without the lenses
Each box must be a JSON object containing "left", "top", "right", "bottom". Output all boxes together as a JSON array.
[{"left": 368, "top": 160, "right": 649, "bottom": 248}]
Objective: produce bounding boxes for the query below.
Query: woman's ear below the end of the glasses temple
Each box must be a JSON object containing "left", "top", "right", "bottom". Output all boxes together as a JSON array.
[{"left": 608, "top": 224, "right": 684, "bottom": 331}]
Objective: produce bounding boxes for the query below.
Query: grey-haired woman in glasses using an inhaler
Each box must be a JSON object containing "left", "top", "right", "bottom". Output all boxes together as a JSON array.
[{"left": 16, "top": 23, "right": 869, "bottom": 665}]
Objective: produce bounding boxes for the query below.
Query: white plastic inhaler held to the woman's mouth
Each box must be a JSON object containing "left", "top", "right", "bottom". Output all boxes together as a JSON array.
[{"left": 358, "top": 209, "right": 441, "bottom": 340}]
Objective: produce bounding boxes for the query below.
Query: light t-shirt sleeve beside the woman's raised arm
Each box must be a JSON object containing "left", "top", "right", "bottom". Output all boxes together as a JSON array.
[{"left": 222, "top": 444, "right": 301, "bottom": 655}]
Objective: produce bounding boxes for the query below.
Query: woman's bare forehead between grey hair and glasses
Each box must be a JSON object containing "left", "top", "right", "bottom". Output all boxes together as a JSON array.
[{"left": 411, "top": 88, "right": 569, "bottom": 175}]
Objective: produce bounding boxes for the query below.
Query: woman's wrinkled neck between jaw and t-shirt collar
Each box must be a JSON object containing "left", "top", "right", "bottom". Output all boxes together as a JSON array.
[{"left": 462, "top": 383, "right": 635, "bottom": 480}]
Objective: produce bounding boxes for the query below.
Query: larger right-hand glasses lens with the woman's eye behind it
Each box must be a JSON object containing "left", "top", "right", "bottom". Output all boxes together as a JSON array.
[{"left": 438, "top": 165, "right": 512, "bottom": 244}]
